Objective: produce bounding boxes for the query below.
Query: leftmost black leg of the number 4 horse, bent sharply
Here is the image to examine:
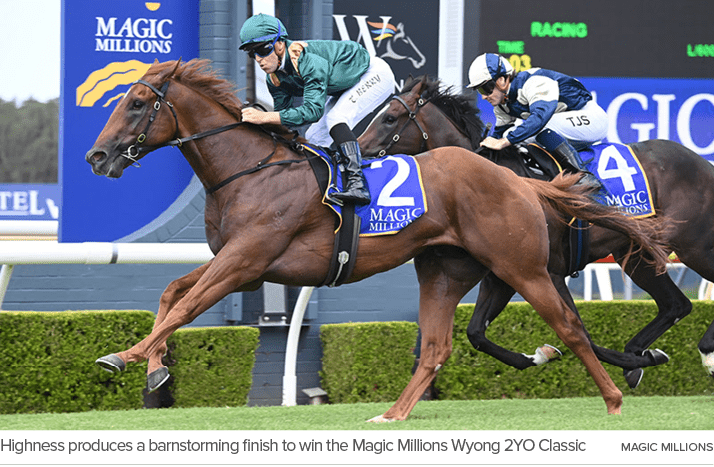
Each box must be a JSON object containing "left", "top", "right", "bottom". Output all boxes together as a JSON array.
[{"left": 466, "top": 272, "right": 535, "bottom": 370}]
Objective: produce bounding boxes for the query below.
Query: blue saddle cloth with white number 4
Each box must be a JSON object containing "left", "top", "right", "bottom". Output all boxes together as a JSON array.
[{"left": 580, "top": 143, "right": 655, "bottom": 218}]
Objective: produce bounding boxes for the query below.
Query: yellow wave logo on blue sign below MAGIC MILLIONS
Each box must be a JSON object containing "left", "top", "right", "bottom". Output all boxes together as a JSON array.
[{"left": 77, "top": 59, "right": 151, "bottom": 107}]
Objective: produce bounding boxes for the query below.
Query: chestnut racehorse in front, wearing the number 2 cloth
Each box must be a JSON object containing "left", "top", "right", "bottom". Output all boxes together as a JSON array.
[{"left": 86, "top": 60, "right": 666, "bottom": 421}]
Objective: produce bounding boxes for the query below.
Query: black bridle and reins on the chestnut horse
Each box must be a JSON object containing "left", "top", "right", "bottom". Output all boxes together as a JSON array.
[{"left": 120, "top": 79, "right": 307, "bottom": 194}]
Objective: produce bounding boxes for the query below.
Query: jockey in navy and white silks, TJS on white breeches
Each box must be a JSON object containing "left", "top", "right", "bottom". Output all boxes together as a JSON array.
[{"left": 468, "top": 53, "right": 608, "bottom": 187}]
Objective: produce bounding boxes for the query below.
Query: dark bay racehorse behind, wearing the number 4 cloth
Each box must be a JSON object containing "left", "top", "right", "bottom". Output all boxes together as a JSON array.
[{"left": 359, "top": 76, "right": 714, "bottom": 388}]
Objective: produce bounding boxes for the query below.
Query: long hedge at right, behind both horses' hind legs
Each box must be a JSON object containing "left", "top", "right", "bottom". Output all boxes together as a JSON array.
[{"left": 435, "top": 300, "right": 714, "bottom": 400}]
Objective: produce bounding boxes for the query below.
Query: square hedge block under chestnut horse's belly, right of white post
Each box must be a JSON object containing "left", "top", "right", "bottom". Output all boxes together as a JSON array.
[{"left": 320, "top": 322, "right": 418, "bottom": 403}]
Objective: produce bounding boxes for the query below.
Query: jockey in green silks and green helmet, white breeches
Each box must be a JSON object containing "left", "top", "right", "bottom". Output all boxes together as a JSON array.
[{"left": 240, "top": 14, "right": 394, "bottom": 204}]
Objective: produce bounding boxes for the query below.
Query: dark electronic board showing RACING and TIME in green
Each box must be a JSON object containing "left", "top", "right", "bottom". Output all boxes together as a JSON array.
[{"left": 478, "top": 0, "right": 714, "bottom": 78}]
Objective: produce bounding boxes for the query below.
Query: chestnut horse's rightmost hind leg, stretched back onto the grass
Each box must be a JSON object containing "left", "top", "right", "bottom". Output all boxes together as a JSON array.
[{"left": 515, "top": 276, "right": 622, "bottom": 414}]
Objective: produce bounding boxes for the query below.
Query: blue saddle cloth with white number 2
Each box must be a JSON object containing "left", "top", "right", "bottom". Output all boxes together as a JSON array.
[{"left": 303, "top": 144, "right": 428, "bottom": 237}]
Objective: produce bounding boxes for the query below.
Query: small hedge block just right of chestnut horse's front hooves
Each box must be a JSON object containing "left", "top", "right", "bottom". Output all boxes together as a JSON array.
[{"left": 168, "top": 327, "right": 260, "bottom": 407}]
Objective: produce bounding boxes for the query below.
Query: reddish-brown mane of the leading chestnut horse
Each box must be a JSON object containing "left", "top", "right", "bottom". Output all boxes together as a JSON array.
[{"left": 146, "top": 58, "right": 294, "bottom": 137}]
